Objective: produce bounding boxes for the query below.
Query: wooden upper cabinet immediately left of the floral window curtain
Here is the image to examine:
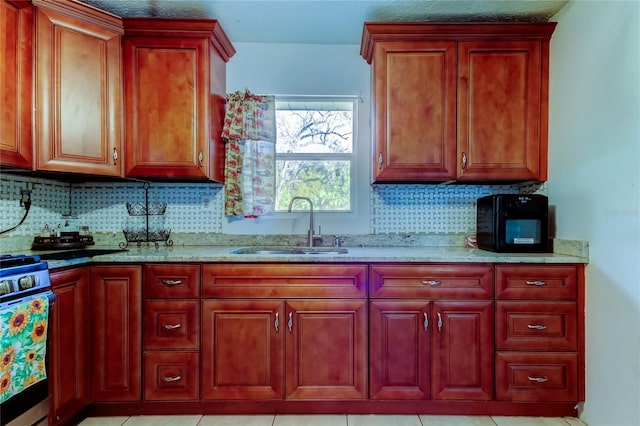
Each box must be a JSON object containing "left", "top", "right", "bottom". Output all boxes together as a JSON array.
[{"left": 124, "top": 18, "right": 235, "bottom": 182}]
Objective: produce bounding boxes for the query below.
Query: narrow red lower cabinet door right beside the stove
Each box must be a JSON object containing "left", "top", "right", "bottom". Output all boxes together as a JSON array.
[{"left": 49, "top": 268, "right": 89, "bottom": 424}]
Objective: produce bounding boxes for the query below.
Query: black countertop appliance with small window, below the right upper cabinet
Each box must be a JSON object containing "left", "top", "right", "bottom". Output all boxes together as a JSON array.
[{"left": 476, "top": 194, "right": 551, "bottom": 253}]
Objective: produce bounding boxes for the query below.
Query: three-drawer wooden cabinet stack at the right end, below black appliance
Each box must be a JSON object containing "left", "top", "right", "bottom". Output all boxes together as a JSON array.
[{"left": 496, "top": 265, "right": 585, "bottom": 403}]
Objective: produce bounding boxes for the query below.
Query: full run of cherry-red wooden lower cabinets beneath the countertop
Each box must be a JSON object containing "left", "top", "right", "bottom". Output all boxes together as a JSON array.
[{"left": 77, "top": 262, "right": 585, "bottom": 419}]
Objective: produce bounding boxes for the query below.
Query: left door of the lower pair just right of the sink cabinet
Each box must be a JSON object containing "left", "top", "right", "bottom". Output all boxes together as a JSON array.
[{"left": 369, "top": 300, "right": 435, "bottom": 399}]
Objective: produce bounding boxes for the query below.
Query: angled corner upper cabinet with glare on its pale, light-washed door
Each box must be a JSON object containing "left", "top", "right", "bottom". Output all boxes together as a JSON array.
[{"left": 33, "top": 0, "right": 123, "bottom": 176}]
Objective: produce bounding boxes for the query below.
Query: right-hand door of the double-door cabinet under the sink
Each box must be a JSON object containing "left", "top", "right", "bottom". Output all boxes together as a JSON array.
[{"left": 283, "top": 300, "right": 367, "bottom": 399}]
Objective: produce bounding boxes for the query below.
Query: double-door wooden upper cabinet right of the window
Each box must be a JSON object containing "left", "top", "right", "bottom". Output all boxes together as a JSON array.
[{"left": 360, "top": 23, "right": 556, "bottom": 183}]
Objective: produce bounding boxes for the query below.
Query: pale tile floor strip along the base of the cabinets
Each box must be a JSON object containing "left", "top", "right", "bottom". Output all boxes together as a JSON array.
[{"left": 80, "top": 414, "right": 586, "bottom": 426}]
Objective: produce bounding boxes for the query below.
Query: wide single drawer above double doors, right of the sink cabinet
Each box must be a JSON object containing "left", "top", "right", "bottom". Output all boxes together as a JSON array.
[{"left": 370, "top": 264, "right": 493, "bottom": 299}]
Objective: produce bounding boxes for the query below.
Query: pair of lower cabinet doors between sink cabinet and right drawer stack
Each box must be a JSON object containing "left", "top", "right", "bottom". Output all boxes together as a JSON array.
[{"left": 369, "top": 300, "right": 493, "bottom": 401}]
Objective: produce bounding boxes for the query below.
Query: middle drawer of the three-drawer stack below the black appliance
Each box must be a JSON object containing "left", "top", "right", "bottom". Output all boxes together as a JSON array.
[{"left": 496, "top": 301, "right": 578, "bottom": 351}]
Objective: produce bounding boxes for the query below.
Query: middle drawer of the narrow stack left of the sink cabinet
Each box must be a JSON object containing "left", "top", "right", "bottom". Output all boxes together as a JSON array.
[{"left": 144, "top": 300, "right": 200, "bottom": 350}]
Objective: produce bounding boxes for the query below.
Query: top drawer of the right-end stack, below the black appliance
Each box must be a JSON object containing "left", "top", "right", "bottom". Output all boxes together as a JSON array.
[{"left": 496, "top": 265, "right": 578, "bottom": 299}]
